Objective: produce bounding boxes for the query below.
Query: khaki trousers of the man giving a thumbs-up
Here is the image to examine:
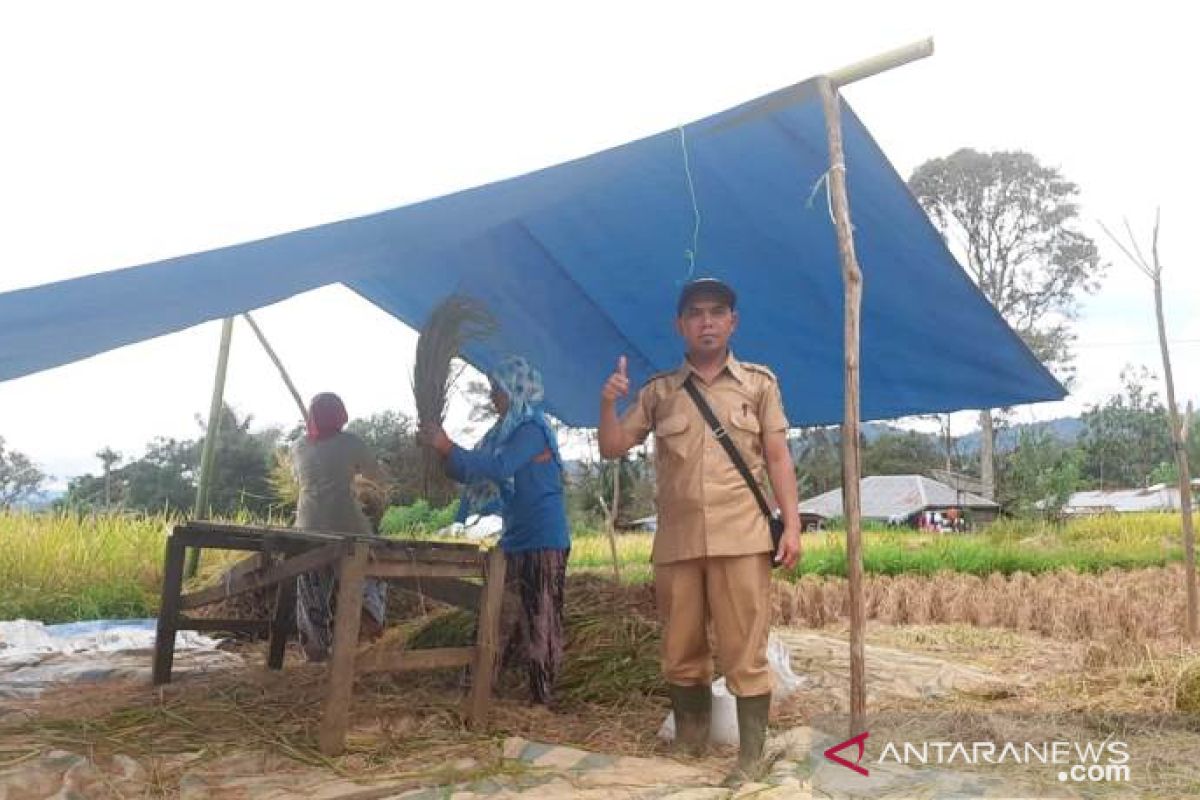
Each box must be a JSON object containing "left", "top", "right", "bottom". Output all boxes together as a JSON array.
[{"left": 654, "top": 553, "right": 770, "bottom": 697}]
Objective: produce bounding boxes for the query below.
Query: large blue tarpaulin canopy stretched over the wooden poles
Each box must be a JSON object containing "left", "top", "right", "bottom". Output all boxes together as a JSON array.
[{"left": 0, "top": 82, "right": 1066, "bottom": 426}]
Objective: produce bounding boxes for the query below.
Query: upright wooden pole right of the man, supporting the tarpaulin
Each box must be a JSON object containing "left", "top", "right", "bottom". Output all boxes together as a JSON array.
[{"left": 818, "top": 78, "right": 866, "bottom": 735}]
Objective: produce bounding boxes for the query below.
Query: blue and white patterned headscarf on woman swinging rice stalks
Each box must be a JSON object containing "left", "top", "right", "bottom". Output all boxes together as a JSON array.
[{"left": 458, "top": 355, "right": 563, "bottom": 521}]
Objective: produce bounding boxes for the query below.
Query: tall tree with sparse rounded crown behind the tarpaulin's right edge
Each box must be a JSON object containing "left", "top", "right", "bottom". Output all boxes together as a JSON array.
[{"left": 908, "top": 149, "right": 1104, "bottom": 496}]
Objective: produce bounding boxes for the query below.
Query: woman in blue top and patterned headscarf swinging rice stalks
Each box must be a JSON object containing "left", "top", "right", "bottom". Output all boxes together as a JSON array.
[{"left": 420, "top": 356, "right": 571, "bottom": 705}]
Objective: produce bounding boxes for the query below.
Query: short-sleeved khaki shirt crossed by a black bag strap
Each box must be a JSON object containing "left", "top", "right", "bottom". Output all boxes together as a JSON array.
[{"left": 620, "top": 355, "right": 787, "bottom": 564}]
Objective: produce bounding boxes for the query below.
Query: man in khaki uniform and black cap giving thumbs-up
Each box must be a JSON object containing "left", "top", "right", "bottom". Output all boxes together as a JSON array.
[{"left": 599, "top": 278, "right": 800, "bottom": 781}]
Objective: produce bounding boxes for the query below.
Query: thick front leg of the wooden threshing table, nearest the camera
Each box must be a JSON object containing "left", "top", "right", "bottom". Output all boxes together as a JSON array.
[{"left": 317, "top": 542, "right": 371, "bottom": 756}]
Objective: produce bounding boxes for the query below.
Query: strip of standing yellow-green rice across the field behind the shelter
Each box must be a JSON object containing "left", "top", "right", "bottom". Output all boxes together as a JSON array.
[{"left": 0, "top": 512, "right": 1182, "bottom": 622}]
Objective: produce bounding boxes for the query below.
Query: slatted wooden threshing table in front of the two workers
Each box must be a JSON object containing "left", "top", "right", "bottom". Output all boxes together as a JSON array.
[{"left": 154, "top": 522, "right": 504, "bottom": 754}]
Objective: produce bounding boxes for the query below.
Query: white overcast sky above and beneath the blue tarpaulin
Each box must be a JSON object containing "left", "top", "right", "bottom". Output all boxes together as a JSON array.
[{"left": 0, "top": 0, "right": 1200, "bottom": 489}]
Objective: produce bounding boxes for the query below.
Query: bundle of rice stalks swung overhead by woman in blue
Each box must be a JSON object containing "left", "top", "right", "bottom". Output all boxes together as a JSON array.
[{"left": 413, "top": 294, "right": 496, "bottom": 475}]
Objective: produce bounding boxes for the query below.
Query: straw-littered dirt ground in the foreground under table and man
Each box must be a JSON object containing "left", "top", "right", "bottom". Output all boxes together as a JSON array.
[{"left": 0, "top": 622, "right": 1200, "bottom": 800}]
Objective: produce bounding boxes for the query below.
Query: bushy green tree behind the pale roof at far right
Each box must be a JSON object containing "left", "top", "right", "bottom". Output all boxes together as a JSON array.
[{"left": 1080, "top": 366, "right": 1172, "bottom": 489}]
